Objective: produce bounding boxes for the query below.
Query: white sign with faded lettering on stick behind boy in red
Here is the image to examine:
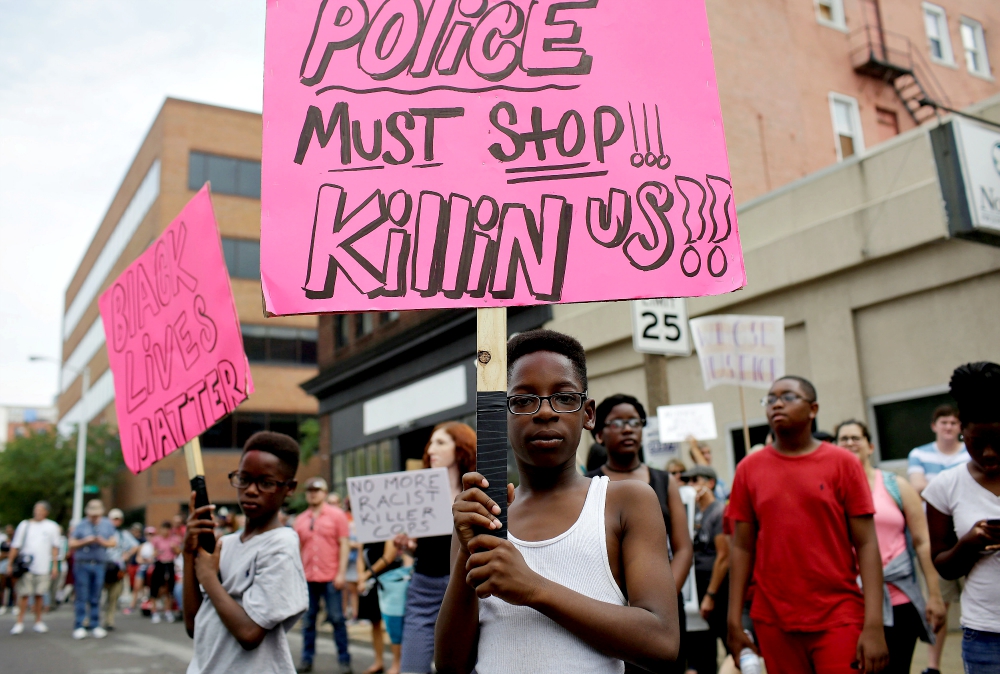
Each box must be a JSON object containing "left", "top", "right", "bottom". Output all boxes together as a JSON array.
[{"left": 690, "top": 314, "right": 785, "bottom": 389}]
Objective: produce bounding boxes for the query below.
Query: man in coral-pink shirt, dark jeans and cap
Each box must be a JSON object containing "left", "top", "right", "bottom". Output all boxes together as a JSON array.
[{"left": 295, "top": 477, "right": 351, "bottom": 672}]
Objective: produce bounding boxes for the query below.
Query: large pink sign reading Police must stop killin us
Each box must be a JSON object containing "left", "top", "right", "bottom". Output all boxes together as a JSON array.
[{"left": 261, "top": 0, "right": 746, "bottom": 314}]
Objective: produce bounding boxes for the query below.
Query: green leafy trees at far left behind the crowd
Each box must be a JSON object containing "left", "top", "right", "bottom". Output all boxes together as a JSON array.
[{"left": 0, "top": 424, "right": 124, "bottom": 526}]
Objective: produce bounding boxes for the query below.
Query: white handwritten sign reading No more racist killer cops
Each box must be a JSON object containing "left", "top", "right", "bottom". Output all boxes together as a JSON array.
[{"left": 347, "top": 468, "right": 454, "bottom": 543}]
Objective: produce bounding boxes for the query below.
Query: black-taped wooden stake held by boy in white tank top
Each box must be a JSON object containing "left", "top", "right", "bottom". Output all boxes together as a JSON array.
[{"left": 476, "top": 307, "right": 508, "bottom": 538}]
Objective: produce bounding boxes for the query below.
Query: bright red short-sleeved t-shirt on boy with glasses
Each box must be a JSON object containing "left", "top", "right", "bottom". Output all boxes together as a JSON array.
[{"left": 729, "top": 442, "right": 875, "bottom": 632}]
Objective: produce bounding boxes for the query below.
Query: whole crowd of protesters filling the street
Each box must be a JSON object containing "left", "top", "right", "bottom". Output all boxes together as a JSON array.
[{"left": 0, "top": 330, "right": 1000, "bottom": 674}]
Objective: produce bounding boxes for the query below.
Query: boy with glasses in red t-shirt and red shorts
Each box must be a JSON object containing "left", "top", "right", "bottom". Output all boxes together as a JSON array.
[{"left": 728, "top": 376, "right": 888, "bottom": 674}]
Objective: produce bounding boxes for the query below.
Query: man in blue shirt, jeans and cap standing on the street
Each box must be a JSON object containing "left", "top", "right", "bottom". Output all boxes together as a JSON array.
[{"left": 69, "top": 498, "right": 118, "bottom": 639}]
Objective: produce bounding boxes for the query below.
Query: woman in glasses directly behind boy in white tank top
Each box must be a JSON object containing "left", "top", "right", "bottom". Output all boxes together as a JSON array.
[{"left": 587, "top": 393, "right": 694, "bottom": 672}]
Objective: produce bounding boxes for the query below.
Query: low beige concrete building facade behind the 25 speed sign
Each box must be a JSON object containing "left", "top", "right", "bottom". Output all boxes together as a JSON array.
[{"left": 546, "top": 95, "right": 1000, "bottom": 481}]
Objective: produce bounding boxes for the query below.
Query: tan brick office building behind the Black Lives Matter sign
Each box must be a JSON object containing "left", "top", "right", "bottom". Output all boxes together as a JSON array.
[{"left": 57, "top": 99, "right": 322, "bottom": 524}]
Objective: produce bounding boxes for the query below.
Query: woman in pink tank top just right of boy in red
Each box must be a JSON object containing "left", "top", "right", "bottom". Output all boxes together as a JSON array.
[{"left": 833, "top": 419, "right": 947, "bottom": 674}]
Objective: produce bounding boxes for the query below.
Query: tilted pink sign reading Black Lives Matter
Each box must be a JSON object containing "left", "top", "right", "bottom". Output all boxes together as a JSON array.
[{"left": 99, "top": 185, "right": 253, "bottom": 473}]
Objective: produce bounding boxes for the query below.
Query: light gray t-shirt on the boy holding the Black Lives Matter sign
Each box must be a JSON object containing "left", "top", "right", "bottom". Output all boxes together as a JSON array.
[{"left": 187, "top": 527, "right": 309, "bottom": 674}]
